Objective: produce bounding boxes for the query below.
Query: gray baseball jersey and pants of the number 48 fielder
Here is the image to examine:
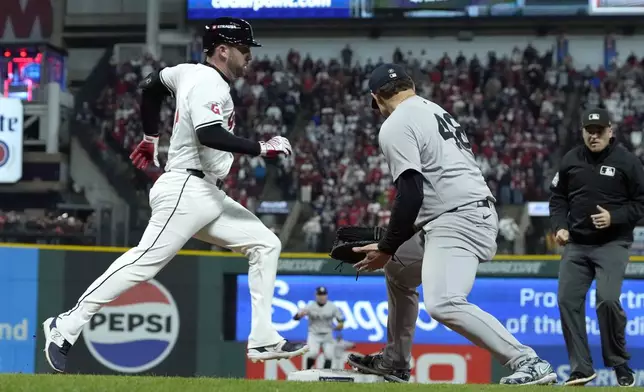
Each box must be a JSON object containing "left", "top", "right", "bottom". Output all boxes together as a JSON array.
[{"left": 379, "top": 96, "right": 536, "bottom": 369}]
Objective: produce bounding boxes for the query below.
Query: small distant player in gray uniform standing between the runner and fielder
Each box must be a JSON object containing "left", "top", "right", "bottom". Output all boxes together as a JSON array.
[{"left": 293, "top": 286, "right": 344, "bottom": 369}]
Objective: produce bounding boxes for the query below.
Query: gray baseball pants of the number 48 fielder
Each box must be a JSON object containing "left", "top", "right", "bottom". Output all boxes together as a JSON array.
[{"left": 383, "top": 205, "right": 537, "bottom": 369}]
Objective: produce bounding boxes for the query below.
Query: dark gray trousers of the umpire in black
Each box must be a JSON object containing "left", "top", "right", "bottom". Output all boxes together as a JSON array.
[{"left": 558, "top": 241, "right": 630, "bottom": 375}]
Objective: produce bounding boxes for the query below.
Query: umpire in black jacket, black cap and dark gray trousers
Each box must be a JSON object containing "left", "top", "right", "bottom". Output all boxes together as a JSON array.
[{"left": 550, "top": 109, "right": 644, "bottom": 387}]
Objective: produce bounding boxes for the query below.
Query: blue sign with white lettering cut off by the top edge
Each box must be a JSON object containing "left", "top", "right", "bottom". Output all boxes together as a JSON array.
[{"left": 186, "top": 0, "right": 352, "bottom": 21}]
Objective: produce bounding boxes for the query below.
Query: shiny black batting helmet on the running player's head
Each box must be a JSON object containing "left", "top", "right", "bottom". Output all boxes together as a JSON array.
[{"left": 202, "top": 17, "right": 262, "bottom": 52}]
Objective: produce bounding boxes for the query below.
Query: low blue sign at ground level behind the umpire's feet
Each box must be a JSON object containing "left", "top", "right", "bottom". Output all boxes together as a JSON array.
[{"left": 536, "top": 345, "right": 644, "bottom": 387}]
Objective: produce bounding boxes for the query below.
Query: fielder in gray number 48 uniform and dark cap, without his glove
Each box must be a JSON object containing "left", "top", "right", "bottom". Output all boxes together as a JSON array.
[{"left": 348, "top": 64, "right": 556, "bottom": 385}]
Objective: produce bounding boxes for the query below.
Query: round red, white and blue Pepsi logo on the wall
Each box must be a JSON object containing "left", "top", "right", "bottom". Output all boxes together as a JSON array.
[{"left": 83, "top": 279, "right": 179, "bottom": 373}]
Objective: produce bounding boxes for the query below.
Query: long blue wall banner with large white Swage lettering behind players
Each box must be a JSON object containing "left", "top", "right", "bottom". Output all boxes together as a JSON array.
[{"left": 236, "top": 275, "right": 644, "bottom": 348}]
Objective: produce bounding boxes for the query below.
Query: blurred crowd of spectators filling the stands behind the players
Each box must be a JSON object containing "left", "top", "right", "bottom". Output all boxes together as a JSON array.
[{"left": 5, "top": 41, "right": 644, "bottom": 250}]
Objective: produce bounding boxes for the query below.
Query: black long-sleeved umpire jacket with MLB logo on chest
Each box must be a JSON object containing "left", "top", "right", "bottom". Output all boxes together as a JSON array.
[{"left": 550, "top": 139, "right": 644, "bottom": 245}]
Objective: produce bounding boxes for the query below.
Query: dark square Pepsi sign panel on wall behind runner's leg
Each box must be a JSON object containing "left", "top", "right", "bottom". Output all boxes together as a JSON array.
[{"left": 61, "top": 252, "right": 198, "bottom": 377}]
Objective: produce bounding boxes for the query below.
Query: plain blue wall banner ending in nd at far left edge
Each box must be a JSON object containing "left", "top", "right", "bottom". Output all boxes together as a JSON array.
[{"left": 0, "top": 248, "right": 38, "bottom": 373}]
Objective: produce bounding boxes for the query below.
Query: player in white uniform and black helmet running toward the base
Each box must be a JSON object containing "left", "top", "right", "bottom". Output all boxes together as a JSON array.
[{"left": 43, "top": 18, "right": 308, "bottom": 372}]
